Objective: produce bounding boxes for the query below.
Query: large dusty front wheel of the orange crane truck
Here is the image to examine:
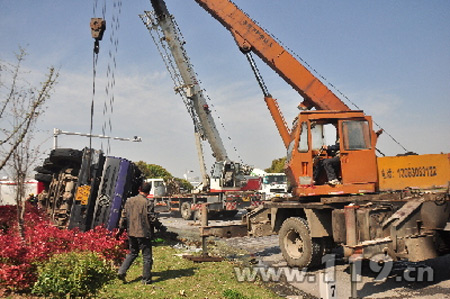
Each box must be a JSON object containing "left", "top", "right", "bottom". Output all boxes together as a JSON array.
[{"left": 278, "top": 217, "right": 323, "bottom": 268}]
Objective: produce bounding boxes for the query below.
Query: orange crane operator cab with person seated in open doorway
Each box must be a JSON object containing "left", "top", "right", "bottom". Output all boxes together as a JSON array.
[{"left": 286, "top": 110, "right": 377, "bottom": 197}]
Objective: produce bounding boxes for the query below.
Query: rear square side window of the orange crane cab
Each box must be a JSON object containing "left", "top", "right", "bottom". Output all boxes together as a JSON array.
[{"left": 342, "top": 120, "right": 371, "bottom": 151}]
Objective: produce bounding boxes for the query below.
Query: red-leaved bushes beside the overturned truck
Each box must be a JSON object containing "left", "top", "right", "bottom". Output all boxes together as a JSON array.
[{"left": 0, "top": 206, "right": 126, "bottom": 293}]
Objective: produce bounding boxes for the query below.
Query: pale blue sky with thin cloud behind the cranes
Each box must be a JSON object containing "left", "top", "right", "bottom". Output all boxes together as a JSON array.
[{"left": 0, "top": 0, "right": 450, "bottom": 176}]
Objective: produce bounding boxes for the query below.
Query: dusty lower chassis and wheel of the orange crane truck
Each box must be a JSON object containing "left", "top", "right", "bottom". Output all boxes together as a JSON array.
[{"left": 244, "top": 190, "right": 450, "bottom": 267}]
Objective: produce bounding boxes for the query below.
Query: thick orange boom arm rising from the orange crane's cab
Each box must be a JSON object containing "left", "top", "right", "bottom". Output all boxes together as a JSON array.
[{"left": 195, "top": 0, "right": 350, "bottom": 111}]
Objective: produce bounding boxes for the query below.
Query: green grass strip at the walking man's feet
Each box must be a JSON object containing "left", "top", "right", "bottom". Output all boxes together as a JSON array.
[{"left": 98, "top": 245, "right": 281, "bottom": 299}]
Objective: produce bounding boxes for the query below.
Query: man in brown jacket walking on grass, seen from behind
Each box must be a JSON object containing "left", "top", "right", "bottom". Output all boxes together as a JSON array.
[{"left": 117, "top": 183, "right": 165, "bottom": 284}]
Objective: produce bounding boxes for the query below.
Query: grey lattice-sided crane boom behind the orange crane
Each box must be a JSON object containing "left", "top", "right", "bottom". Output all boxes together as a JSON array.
[{"left": 140, "top": 0, "right": 259, "bottom": 193}]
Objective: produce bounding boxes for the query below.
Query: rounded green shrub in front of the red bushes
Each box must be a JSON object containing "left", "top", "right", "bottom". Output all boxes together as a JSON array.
[{"left": 32, "top": 252, "right": 114, "bottom": 298}]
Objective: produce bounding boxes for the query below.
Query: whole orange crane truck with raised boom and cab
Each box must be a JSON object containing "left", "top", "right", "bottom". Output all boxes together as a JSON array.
[{"left": 180, "top": 0, "right": 450, "bottom": 267}]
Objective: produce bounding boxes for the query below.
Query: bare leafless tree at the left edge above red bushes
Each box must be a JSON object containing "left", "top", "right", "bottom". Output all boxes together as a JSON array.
[{"left": 0, "top": 48, "right": 58, "bottom": 239}]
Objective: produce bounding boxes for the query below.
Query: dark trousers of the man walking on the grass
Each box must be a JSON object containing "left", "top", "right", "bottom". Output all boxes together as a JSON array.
[{"left": 119, "top": 236, "right": 153, "bottom": 282}]
